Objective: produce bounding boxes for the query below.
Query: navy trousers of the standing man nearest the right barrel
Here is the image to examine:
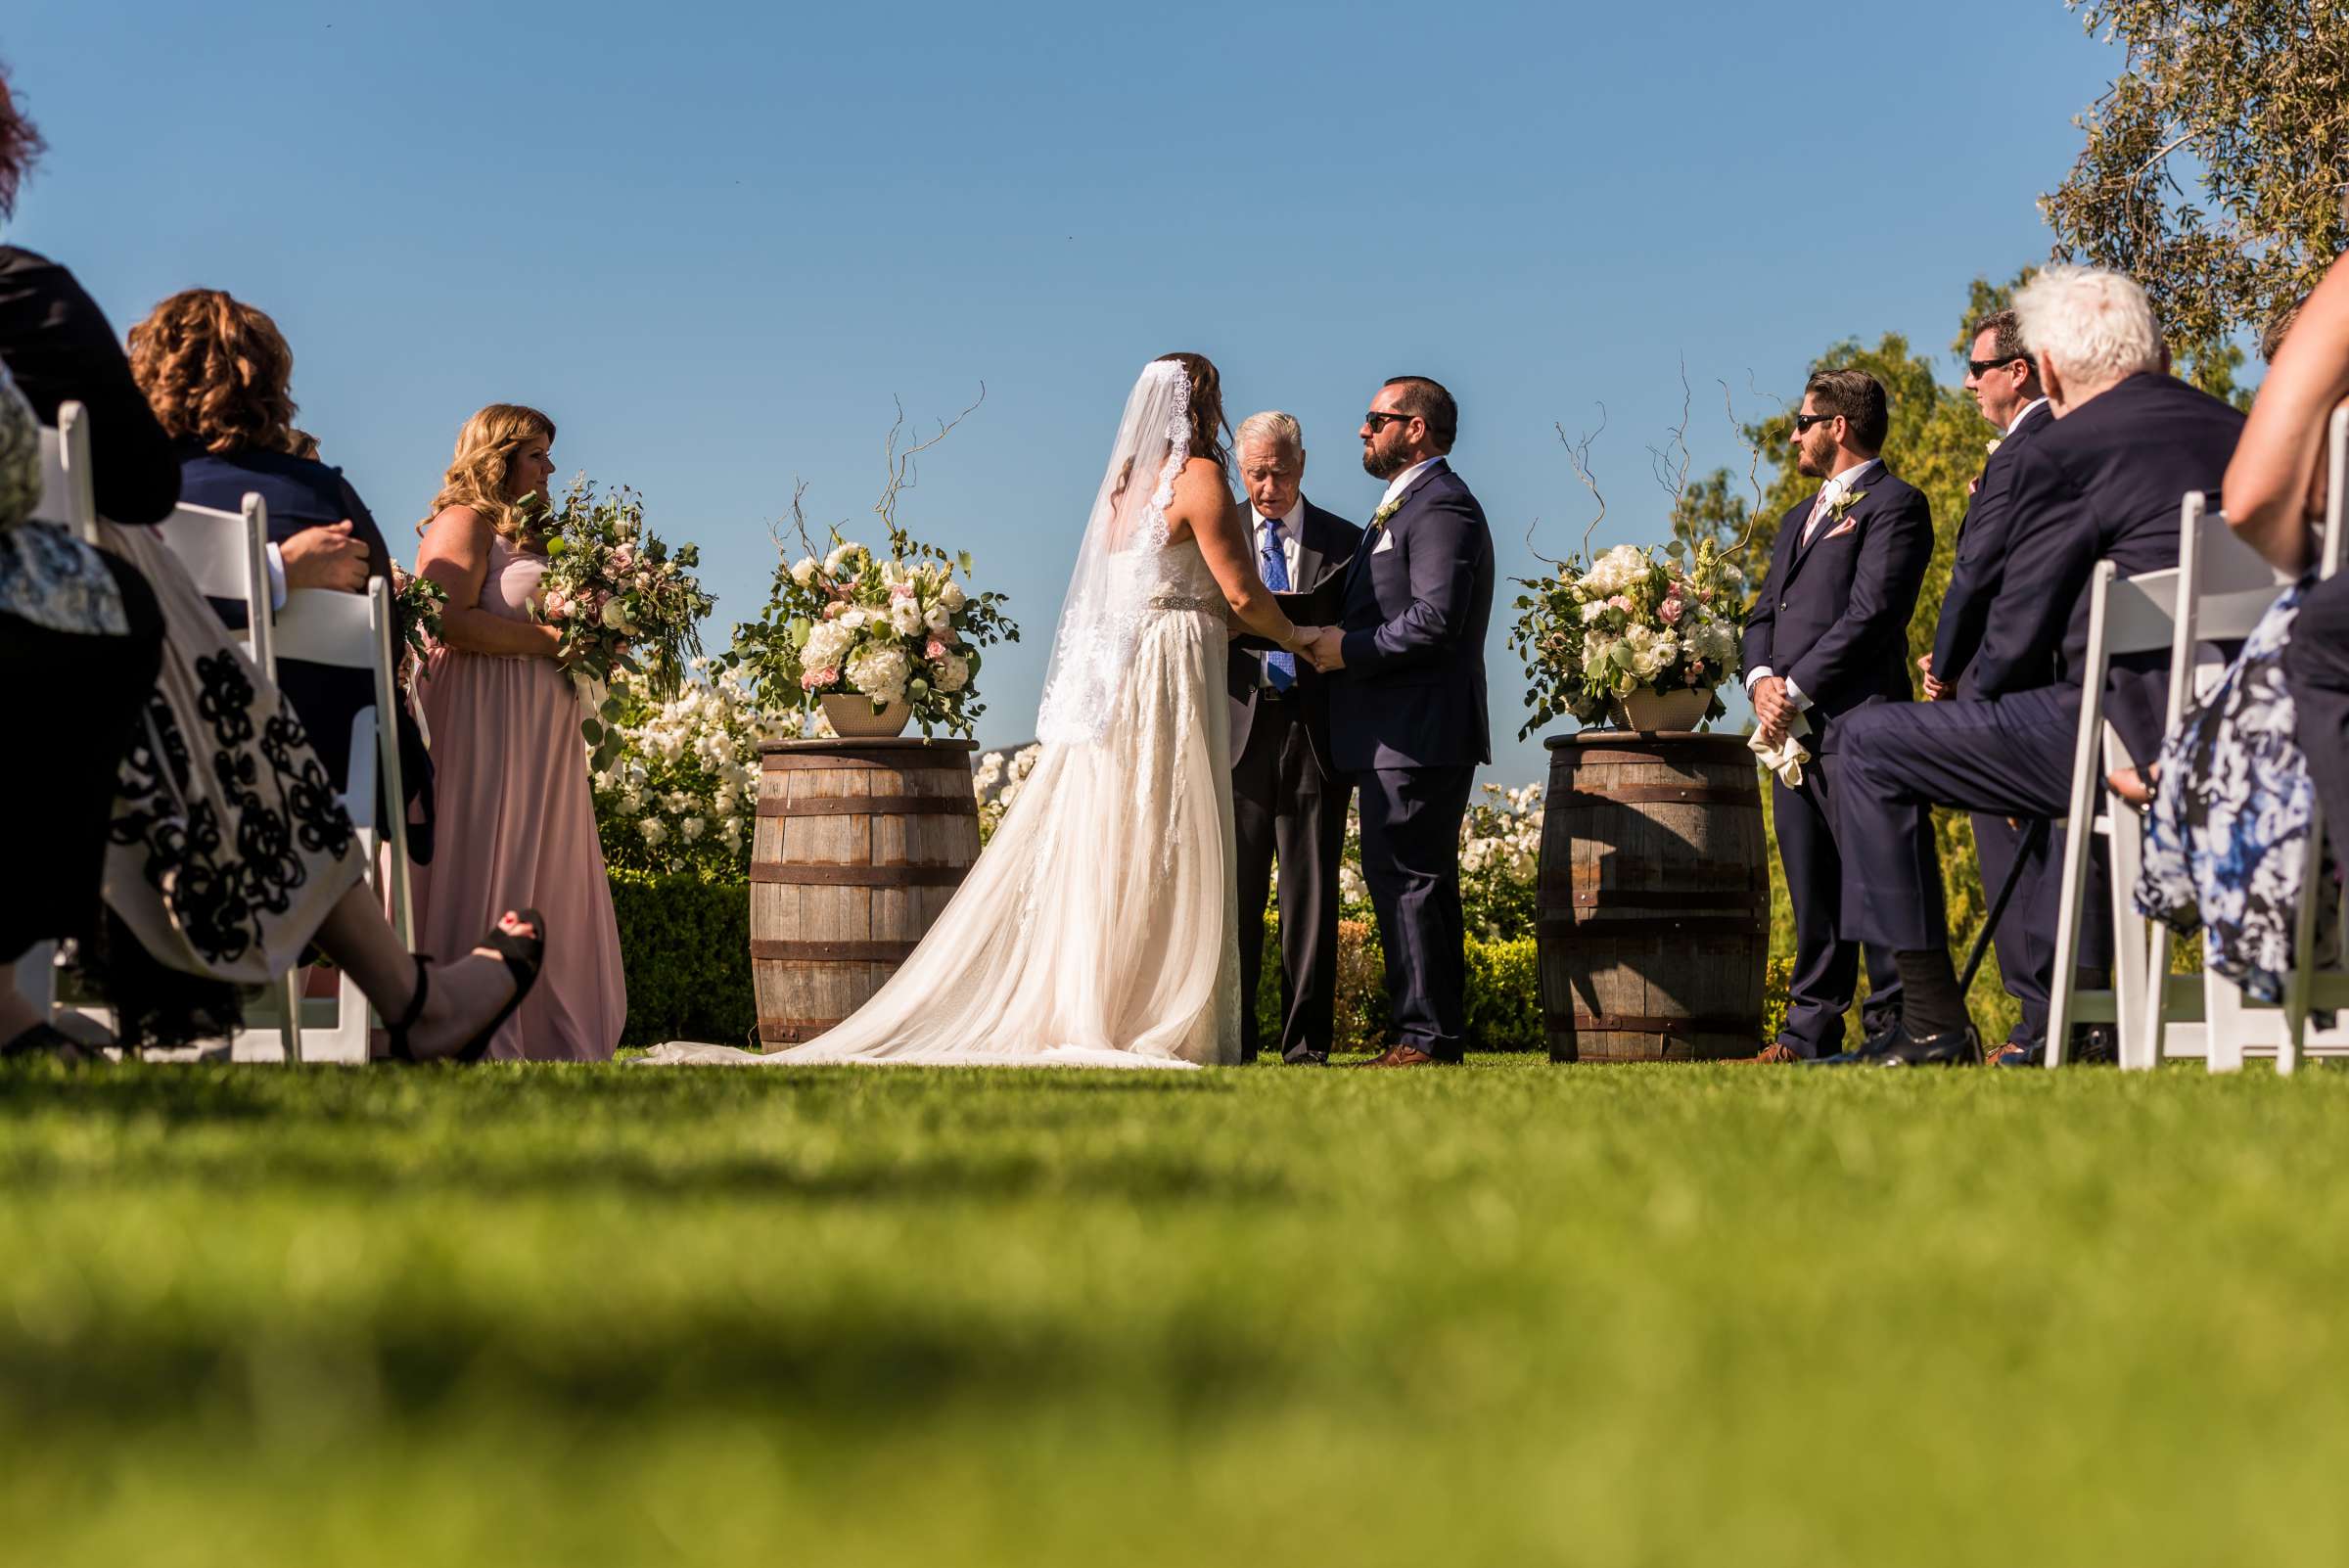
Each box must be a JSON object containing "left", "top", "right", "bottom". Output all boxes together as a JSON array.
[{"left": 1772, "top": 756, "right": 1907, "bottom": 1056}]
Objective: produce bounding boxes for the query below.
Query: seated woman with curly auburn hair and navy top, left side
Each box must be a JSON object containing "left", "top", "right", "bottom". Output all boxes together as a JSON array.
[{"left": 131, "top": 289, "right": 392, "bottom": 789}]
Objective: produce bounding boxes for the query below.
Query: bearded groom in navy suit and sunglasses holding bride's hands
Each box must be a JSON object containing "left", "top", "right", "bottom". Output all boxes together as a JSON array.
[{"left": 1311, "top": 376, "right": 1492, "bottom": 1068}]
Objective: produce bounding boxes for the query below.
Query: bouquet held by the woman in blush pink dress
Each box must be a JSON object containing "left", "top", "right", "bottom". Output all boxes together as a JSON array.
[{"left": 530, "top": 477, "right": 716, "bottom": 767}]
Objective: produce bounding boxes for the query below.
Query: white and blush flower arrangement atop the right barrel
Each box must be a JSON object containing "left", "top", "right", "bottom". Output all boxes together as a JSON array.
[{"left": 1508, "top": 540, "right": 1745, "bottom": 739}]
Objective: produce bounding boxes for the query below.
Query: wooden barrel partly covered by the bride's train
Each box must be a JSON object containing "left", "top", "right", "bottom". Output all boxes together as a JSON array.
[{"left": 750, "top": 737, "right": 980, "bottom": 1049}]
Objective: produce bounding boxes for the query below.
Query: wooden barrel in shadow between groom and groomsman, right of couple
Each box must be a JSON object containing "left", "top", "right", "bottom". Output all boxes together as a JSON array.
[{"left": 1534, "top": 730, "right": 1769, "bottom": 1061}]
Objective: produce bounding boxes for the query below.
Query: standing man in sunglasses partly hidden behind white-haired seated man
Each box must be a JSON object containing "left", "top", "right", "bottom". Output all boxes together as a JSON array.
[{"left": 1924, "top": 310, "right": 2055, "bottom": 1051}]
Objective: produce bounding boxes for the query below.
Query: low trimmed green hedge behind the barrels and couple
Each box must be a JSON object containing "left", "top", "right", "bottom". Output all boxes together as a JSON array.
[{"left": 611, "top": 871, "right": 1543, "bottom": 1051}]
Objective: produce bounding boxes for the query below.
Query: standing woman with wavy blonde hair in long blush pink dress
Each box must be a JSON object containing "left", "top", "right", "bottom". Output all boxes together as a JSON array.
[{"left": 413, "top": 403, "right": 627, "bottom": 1061}]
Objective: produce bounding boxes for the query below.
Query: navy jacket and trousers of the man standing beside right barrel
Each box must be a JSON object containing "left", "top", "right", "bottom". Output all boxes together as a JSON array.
[{"left": 1743, "top": 460, "right": 1933, "bottom": 1056}]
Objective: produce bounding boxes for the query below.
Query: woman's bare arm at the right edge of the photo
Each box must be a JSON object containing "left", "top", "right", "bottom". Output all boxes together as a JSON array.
[{"left": 2227, "top": 260, "right": 2349, "bottom": 573}]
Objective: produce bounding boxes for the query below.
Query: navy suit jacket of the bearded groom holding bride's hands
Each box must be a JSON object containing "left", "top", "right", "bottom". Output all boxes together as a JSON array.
[{"left": 1329, "top": 458, "right": 1492, "bottom": 772}]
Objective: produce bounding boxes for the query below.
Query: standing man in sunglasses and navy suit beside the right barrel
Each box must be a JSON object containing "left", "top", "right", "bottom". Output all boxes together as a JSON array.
[{"left": 1745, "top": 371, "right": 1938, "bottom": 1061}]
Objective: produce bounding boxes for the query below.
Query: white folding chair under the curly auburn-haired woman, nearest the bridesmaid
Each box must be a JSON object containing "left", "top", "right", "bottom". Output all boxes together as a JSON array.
[{"left": 240, "top": 577, "right": 416, "bottom": 1066}]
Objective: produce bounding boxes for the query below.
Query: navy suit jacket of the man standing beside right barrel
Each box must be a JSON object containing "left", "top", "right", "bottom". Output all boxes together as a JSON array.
[{"left": 1743, "top": 458, "right": 1933, "bottom": 756}]
